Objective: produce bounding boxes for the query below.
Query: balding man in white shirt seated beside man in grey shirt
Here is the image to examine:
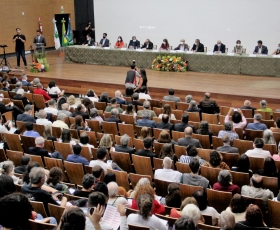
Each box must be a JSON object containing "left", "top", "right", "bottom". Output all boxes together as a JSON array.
[{"left": 154, "top": 157, "right": 182, "bottom": 183}]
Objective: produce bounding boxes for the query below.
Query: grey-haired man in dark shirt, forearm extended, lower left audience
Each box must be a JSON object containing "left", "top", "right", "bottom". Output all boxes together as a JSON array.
[{"left": 21, "top": 167, "right": 67, "bottom": 216}]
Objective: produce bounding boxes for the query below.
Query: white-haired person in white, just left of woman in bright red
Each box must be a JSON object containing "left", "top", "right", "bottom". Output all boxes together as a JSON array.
[{"left": 107, "top": 181, "right": 131, "bottom": 208}]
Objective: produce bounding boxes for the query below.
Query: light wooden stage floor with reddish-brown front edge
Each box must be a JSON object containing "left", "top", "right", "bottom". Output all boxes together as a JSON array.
[{"left": 3, "top": 51, "right": 280, "bottom": 109}]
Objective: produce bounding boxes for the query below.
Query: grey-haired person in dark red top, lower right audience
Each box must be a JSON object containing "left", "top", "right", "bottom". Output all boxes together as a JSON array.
[{"left": 213, "top": 170, "right": 240, "bottom": 195}]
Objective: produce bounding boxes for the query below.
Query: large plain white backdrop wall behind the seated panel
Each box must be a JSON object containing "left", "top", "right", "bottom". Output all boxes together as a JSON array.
[{"left": 93, "top": 0, "right": 280, "bottom": 54}]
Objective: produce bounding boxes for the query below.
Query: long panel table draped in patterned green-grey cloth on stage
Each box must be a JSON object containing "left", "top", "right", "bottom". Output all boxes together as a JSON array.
[{"left": 65, "top": 45, "right": 280, "bottom": 77}]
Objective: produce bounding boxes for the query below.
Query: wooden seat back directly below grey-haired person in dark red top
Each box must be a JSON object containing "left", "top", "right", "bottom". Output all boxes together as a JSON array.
[{"left": 207, "top": 189, "right": 232, "bottom": 213}]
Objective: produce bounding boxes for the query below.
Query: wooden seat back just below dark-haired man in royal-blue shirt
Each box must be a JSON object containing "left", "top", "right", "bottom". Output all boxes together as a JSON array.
[{"left": 64, "top": 161, "right": 85, "bottom": 185}]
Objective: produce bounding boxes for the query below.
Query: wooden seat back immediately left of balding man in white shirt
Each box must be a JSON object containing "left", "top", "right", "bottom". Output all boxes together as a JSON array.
[{"left": 132, "top": 154, "right": 154, "bottom": 178}]
